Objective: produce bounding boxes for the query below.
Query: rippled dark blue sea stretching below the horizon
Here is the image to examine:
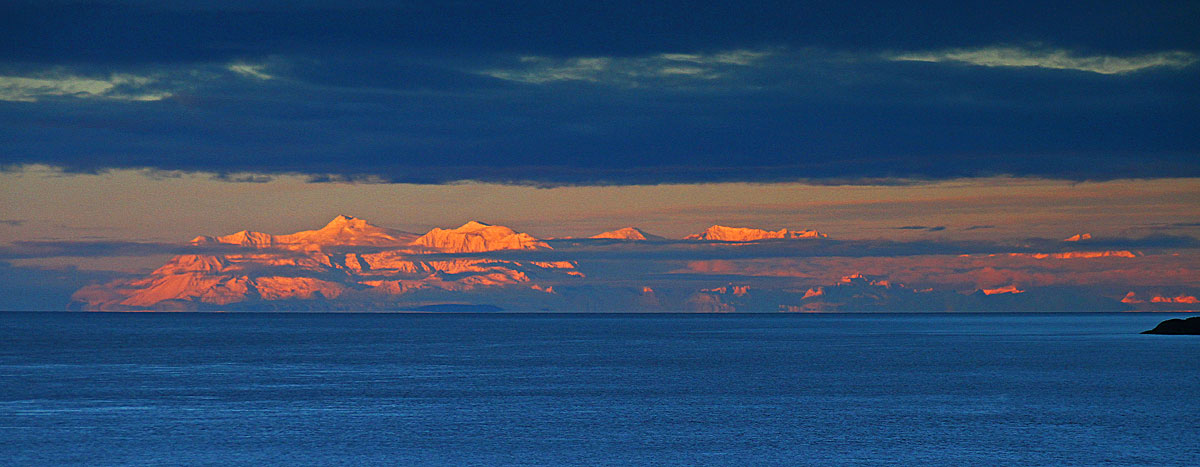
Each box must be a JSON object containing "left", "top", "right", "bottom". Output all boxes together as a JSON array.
[{"left": 0, "top": 313, "right": 1200, "bottom": 466}]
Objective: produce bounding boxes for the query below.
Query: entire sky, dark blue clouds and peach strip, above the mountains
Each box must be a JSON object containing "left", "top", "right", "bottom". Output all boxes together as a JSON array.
[{"left": 0, "top": 0, "right": 1200, "bottom": 307}]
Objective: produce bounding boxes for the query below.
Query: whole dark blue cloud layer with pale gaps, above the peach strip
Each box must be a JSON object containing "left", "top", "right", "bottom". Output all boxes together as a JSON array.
[{"left": 0, "top": 1, "right": 1200, "bottom": 182}]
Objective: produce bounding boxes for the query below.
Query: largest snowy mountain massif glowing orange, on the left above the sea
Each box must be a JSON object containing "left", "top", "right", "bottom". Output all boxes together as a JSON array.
[{"left": 73, "top": 216, "right": 582, "bottom": 310}]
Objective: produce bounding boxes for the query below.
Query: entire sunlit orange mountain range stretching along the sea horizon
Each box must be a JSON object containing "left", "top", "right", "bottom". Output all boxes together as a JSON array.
[{"left": 70, "top": 216, "right": 1187, "bottom": 312}]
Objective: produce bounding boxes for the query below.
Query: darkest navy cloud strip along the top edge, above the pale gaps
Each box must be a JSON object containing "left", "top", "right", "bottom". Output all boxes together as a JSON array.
[{"left": 0, "top": 0, "right": 1200, "bottom": 62}]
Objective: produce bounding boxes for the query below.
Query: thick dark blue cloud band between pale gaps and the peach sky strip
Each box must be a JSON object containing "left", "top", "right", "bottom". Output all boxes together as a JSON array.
[{"left": 0, "top": 58, "right": 1200, "bottom": 185}]
